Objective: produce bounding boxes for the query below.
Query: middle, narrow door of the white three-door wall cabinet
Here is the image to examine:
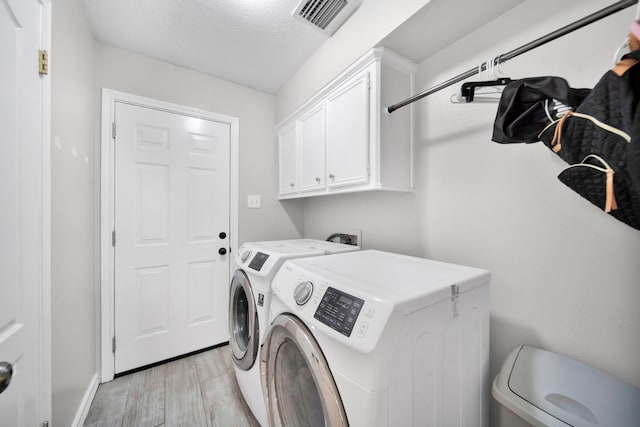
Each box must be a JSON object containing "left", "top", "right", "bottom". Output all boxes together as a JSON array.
[{"left": 298, "top": 102, "right": 326, "bottom": 191}]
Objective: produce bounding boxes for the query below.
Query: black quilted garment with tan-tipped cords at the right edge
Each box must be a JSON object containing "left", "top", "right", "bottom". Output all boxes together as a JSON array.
[{"left": 540, "top": 52, "right": 640, "bottom": 229}]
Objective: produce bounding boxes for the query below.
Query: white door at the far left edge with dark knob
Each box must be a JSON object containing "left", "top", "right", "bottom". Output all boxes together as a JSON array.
[{"left": 0, "top": 0, "right": 49, "bottom": 426}]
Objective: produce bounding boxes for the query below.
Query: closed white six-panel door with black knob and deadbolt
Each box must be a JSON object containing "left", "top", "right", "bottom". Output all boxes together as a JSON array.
[{"left": 114, "top": 102, "right": 231, "bottom": 373}]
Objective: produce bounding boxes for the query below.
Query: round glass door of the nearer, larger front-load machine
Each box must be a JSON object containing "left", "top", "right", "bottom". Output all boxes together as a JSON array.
[{"left": 260, "top": 314, "right": 348, "bottom": 427}]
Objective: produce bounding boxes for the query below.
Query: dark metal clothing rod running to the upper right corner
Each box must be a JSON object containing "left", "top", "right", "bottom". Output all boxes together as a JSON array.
[{"left": 387, "top": 0, "right": 638, "bottom": 113}]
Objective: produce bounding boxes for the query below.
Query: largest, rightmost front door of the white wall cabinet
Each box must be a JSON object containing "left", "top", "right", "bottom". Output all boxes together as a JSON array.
[{"left": 326, "top": 72, "right": 369, "bottom": 187}]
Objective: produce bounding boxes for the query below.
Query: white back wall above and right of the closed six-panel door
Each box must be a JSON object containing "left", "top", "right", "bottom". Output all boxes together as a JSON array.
[{"left": 96, "top": 43, "right": 302, "bottom": 247}]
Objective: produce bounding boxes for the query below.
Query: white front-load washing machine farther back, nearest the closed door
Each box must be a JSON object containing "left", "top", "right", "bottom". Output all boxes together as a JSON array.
[{"left": 229, "top": 239, "right": 360, "bottom": 426}]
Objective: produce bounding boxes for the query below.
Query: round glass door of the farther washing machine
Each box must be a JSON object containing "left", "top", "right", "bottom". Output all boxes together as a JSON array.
[{"left": 229, "top": 270, "right": 260, "bottom": 371}]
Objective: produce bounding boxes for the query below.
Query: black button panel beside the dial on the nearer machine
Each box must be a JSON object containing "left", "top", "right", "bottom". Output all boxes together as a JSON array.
[{"left": 313, "top": 287, "right": 364, "bottom": 337}]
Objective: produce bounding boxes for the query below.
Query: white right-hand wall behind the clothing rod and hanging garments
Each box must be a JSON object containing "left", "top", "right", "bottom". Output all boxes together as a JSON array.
[{"left": 283, "top": 0, "right": 640, "bottom": 425}]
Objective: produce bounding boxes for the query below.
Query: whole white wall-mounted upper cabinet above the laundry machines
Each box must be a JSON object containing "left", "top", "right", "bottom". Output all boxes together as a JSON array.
[{"left": 277, "top": 48, "right": 416, "bottom": 199}]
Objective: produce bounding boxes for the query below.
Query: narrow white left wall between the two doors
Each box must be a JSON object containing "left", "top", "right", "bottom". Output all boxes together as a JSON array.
[{"left": 50, "top": 0, "right": 98, "bottom": 426}]
